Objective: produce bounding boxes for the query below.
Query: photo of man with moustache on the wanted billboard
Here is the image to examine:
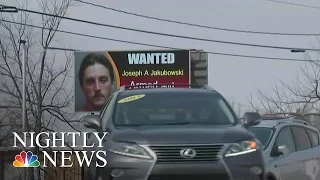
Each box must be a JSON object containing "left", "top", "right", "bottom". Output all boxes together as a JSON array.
[{"left": 75, "top": 52, "right": 117, "bottom": 112}]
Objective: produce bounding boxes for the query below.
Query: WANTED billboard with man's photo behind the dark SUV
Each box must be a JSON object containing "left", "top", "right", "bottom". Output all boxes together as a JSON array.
[{"left": 75, "top": 50, "right": 191, "bottom": 112}]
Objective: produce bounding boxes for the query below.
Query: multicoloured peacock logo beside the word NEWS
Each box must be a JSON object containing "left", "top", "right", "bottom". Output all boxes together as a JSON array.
[{"left": 13, "top": 151, "right": 40, "bottom": 167}]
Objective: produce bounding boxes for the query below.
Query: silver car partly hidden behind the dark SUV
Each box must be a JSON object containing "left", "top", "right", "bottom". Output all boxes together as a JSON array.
[{"left": 249, "top": 118, "right": 320, "bottom": 180}]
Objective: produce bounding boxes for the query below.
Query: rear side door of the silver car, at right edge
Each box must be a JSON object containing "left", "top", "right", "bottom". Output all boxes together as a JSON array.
[{"left": 291, "top": 126, "right": 320, "bottom": 180}]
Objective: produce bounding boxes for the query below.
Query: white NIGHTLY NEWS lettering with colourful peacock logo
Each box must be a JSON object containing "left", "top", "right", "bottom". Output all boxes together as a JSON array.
[{"left": 13, "top": 132, "right": 108, "bottom": 167}]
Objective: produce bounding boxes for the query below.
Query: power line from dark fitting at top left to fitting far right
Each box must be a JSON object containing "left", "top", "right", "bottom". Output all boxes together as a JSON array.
[{"left": 14, "top": 9, "right": 320, "bottom": 51}]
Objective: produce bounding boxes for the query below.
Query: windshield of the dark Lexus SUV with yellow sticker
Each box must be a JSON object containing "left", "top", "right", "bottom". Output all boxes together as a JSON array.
[{"left": 113, "top": 92, "right": 236, "bottom": 126}]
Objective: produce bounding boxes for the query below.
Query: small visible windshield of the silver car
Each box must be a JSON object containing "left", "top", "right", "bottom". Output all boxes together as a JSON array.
[{"left": 249, "top": 127, "right": 273, "bottom": 147}]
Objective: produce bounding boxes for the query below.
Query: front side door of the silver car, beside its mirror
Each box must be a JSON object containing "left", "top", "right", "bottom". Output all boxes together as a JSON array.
[{"left": 271, "top": 126, "right": 301, "bottom": 180}]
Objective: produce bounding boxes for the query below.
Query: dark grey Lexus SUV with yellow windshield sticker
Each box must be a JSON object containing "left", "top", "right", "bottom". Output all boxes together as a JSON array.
[{"left": 84, "top": 86, "right": 264, "bottom": 180}]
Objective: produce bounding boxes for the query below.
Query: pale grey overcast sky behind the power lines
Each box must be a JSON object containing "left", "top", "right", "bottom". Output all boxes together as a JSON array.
[{"left": 0, "top": 0, "right": 320, "bottom": 112}]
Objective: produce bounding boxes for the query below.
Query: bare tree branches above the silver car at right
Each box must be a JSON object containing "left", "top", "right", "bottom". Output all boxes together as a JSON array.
[{"left": 248, "top": 54, "right": 320, "bottom": 119}]
